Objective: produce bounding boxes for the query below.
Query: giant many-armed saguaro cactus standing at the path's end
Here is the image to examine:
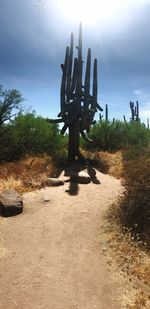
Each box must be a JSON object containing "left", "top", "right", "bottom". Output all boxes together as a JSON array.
[{"left": 51, "top": 24, "right": 103, "bottom": 161}]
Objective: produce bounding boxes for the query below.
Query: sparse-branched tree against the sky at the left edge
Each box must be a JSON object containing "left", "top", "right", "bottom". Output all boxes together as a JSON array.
[{"left": 0, "top": 85, "right": 24, "bottom": 128}]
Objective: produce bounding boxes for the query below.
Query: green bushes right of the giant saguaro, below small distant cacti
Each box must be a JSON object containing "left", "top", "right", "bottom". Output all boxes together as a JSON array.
[{"left": 86, "top": 120, "right": 150, "bottom": 151}]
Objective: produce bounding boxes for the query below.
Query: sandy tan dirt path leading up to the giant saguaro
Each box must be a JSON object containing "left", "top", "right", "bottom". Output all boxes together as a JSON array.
[{"left": 0, "top": 172, "right": 125, "bottom": 309}]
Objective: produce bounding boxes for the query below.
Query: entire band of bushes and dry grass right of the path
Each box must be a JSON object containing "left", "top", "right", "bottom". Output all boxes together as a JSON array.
[{"left": 83, "top": 120, "right": 150, "bottom": 309}]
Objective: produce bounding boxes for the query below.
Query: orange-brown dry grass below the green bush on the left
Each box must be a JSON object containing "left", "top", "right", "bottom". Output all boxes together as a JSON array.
[{"left": 0, "top": 155, "right": 55, "bottom": 193}]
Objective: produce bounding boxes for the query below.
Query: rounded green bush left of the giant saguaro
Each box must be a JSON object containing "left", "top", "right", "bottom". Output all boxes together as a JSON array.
[{"left": 0, "top": 113, "right": 66, "bottom": 160}]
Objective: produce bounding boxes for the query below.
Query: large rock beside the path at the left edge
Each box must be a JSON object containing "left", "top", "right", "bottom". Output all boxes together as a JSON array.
[{"left": 0, "top": 190, "right": 23, "bottom": 217}]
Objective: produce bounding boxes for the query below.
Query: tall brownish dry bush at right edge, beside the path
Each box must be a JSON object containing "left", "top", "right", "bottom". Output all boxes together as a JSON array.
[{"left": 120, "top": 148, "right": 150, "bottom": 243}]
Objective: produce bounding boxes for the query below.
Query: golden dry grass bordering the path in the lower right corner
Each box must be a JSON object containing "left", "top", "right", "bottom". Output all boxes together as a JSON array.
[{"left": 102, "top": 205, "right": 150, "bottom": 309}]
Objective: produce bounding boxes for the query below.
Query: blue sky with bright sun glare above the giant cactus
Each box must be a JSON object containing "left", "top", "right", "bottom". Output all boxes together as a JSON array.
[{"left": 0, "top": 0, "right": 150, "bottom": 122}]
